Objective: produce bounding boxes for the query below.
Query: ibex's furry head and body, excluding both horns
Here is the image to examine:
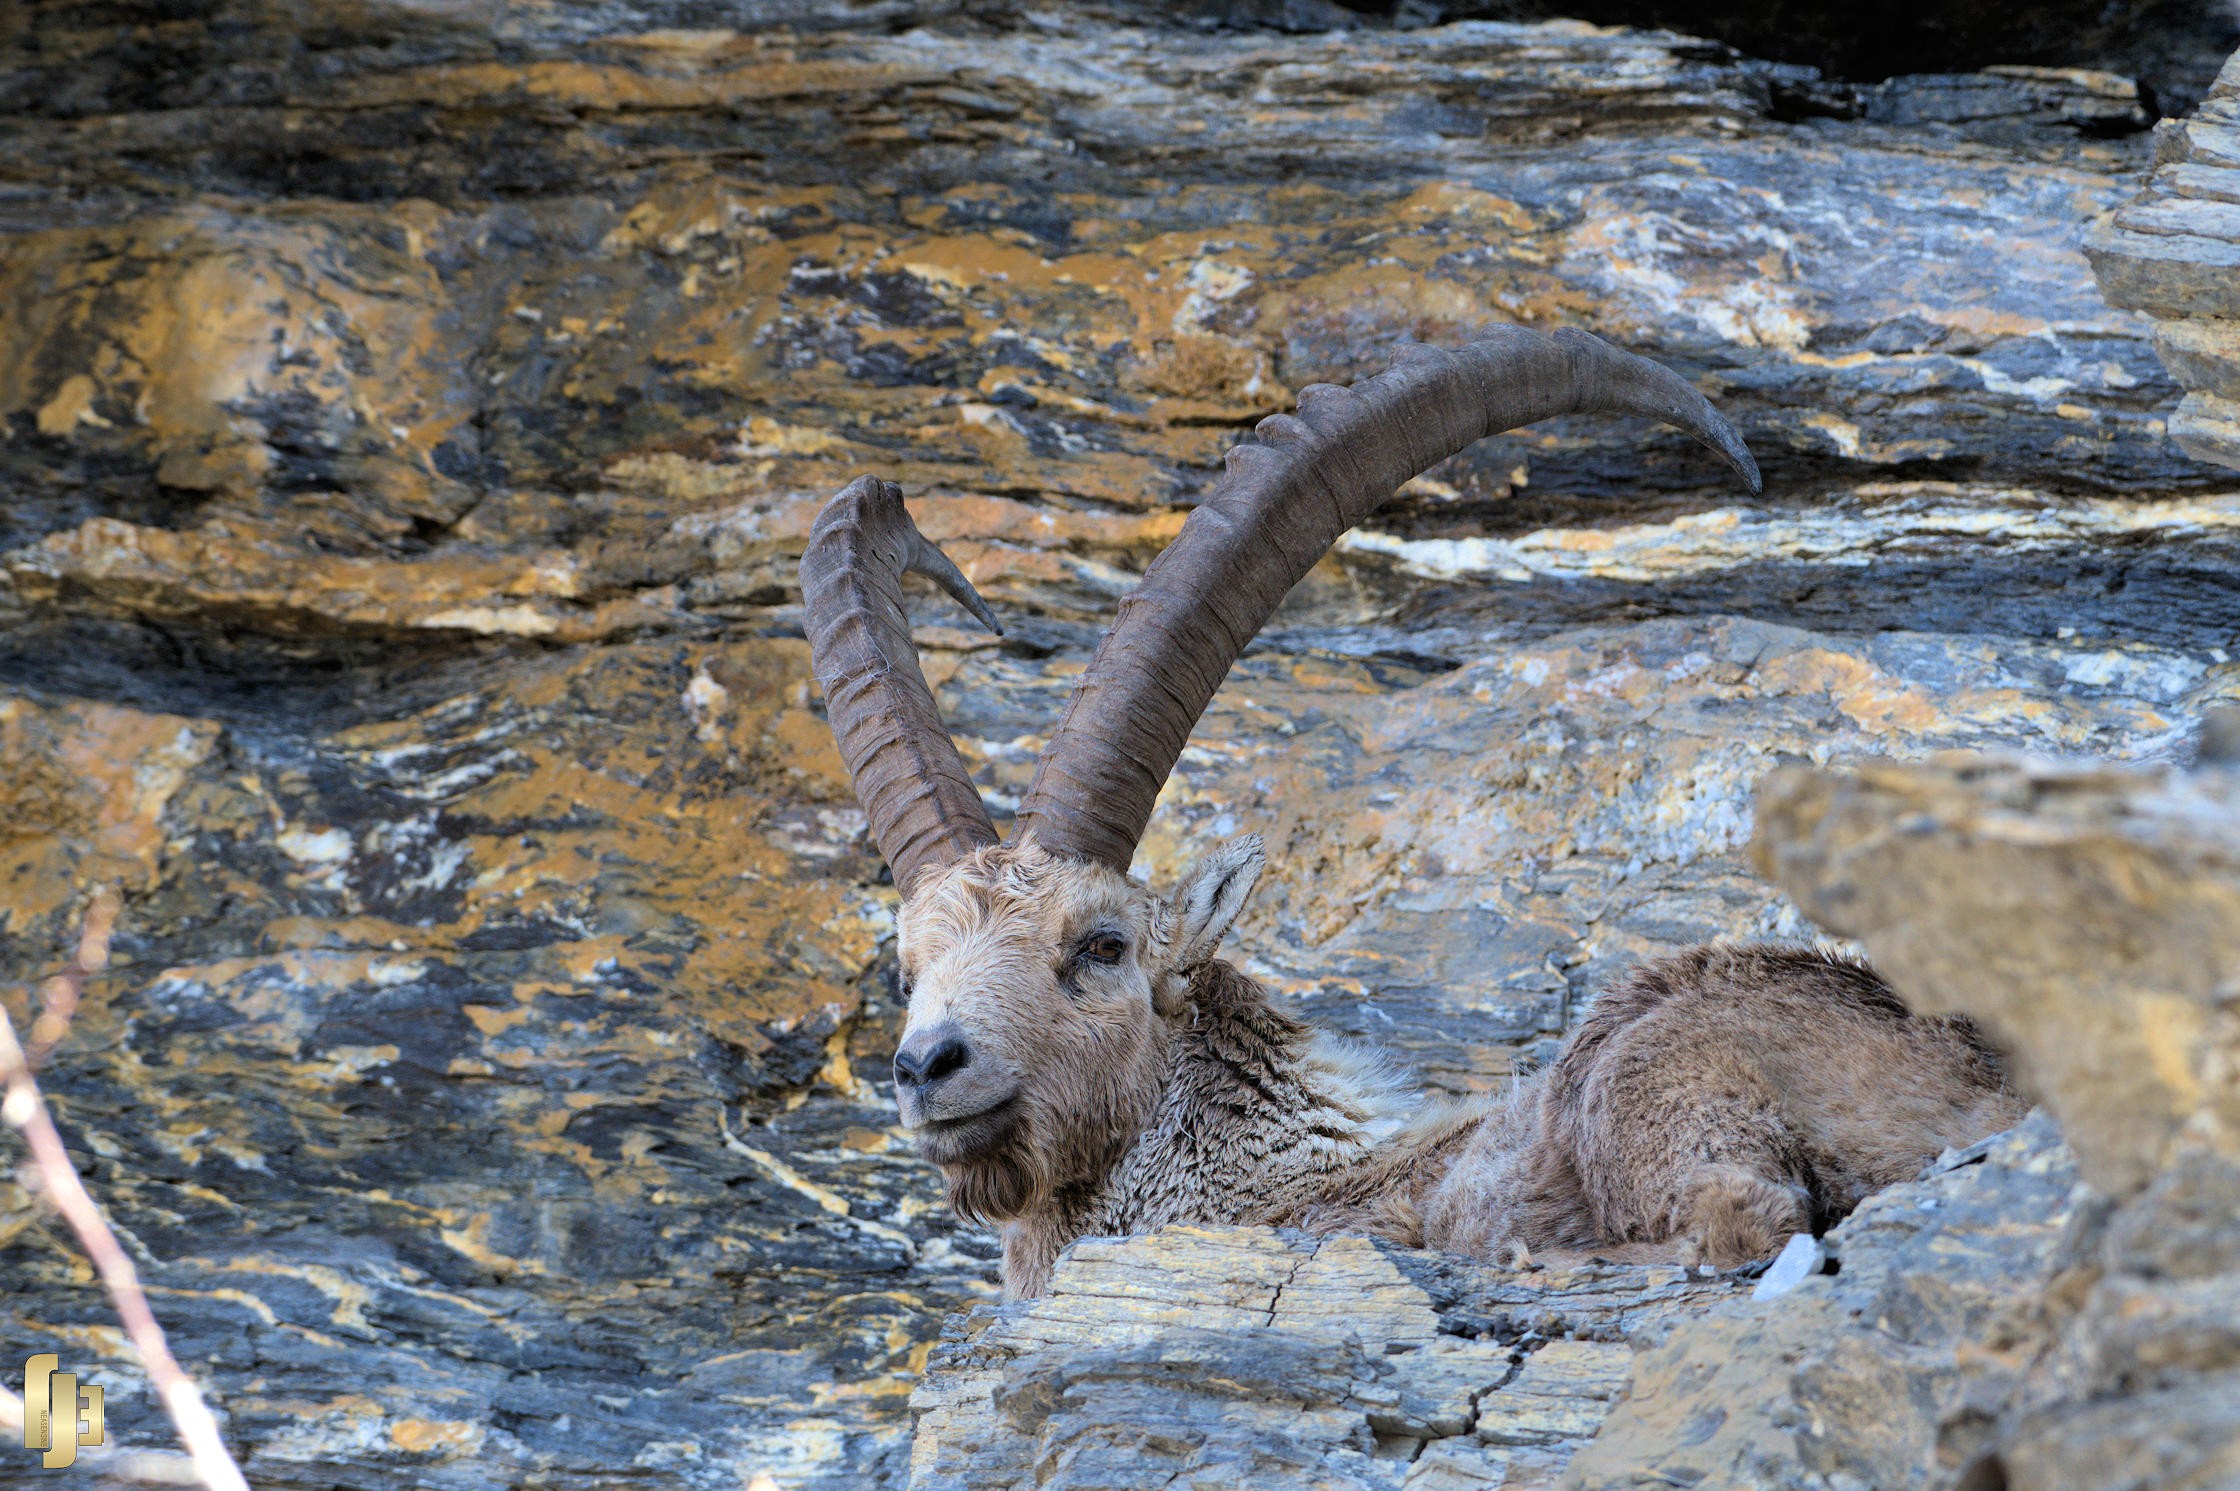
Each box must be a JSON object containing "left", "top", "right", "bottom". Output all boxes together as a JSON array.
[{"left": 903, "top": 842, "right": 2023, "bottom": 1298}]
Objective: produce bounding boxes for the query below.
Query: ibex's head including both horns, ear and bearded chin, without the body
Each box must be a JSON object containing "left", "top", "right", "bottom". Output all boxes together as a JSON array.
[{"left": 802, "top": 327, "right": 1758, "bottom": 1220}]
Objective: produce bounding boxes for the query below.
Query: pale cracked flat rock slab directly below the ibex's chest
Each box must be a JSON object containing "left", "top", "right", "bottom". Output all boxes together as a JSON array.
[{"left": 909, "top": 1227, "right": 1738, "bottom": 1491}]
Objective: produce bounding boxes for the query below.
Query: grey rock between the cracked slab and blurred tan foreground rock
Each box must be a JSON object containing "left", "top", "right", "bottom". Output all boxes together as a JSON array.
[{"left": 1564, "top": 1115, "right": 2088, "bottom": 1491}]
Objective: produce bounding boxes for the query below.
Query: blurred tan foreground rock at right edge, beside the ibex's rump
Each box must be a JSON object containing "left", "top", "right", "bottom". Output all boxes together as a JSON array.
[{"left": 1763, "top": 756, "right": 2240, "bottom": 1491}]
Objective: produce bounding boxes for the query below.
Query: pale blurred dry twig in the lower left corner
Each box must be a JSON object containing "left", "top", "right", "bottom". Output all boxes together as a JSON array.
[{"left": 0, "top": 889, "right": 249, "bottom": 1491}]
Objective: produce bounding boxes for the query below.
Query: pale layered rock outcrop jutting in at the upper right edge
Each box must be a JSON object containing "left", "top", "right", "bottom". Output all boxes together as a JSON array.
[{"left": 2085, "top": 51, "right": 2240, "bottom": 466}]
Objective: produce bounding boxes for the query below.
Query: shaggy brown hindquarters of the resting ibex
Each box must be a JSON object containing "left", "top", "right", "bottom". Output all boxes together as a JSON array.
[{"left": 1425, "top": 945, "right": 2023, "bottom": 1267}]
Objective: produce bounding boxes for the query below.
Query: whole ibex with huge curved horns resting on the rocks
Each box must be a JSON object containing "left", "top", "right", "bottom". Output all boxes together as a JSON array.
[{"left": 802, "top": 327, "right": 2020, "bottom": 1298}]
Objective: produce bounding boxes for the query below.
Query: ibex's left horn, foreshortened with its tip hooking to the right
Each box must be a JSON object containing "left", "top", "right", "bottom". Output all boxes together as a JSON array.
[{"left": 802, "top": 477, "right": 1004, "bottom": 895}]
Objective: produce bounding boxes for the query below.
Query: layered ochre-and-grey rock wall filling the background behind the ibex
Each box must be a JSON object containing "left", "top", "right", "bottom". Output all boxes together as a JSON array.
[{"left": 0, "top": 0, "right": 2240, "bottom": 1489}]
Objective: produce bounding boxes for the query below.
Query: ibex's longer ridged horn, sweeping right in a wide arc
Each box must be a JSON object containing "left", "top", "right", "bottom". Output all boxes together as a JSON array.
[{"left": 1015, "top": 327, "right": 1761, "bottom": 873}]
